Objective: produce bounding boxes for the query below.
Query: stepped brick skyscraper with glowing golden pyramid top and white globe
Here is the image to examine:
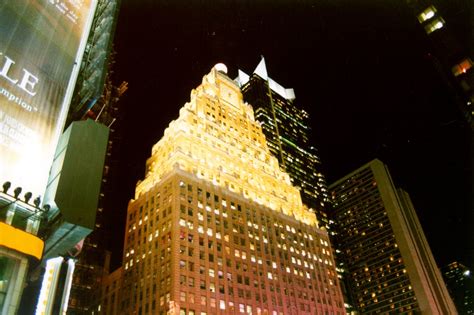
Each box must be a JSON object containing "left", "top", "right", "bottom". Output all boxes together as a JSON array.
[{"left": 121, "top": 64, "right": 344, "bottom": 315}]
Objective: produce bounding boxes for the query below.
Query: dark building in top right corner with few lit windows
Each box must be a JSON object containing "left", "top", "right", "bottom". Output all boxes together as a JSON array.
[{"left": 407, "top": 0, "right": 474, "bottom": 129}]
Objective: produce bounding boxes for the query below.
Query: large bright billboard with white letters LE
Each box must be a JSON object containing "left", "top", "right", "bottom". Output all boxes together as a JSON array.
[{"left": 0, "top": 0, "right": 97, "bottom": 200}]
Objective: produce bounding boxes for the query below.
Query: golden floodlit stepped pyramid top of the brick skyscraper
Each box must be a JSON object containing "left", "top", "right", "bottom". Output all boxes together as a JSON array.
[{"left": 136, "top": 64, "right": 317, "bottom": 225}]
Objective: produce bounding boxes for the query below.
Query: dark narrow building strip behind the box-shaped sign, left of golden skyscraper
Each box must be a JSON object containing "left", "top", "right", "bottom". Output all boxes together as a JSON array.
[{"left": 68, "top": 77, "right": 127, "bottom": 314}]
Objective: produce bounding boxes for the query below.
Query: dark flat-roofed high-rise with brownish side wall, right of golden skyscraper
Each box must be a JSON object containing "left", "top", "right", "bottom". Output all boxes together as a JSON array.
[{"left": 329, "top": 160, "right": 457, "bottom": 314}]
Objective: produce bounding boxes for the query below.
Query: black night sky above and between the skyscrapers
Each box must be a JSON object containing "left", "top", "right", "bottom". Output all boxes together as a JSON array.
[{"left": 108, "top": 0, "right": 474, "bottom": 268}]
